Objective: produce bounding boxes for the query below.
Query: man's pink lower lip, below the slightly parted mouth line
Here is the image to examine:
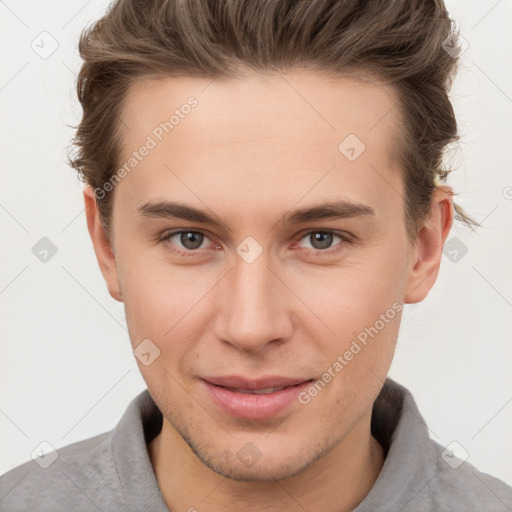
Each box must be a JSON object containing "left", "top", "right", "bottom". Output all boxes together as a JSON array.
[{"left": 202, "top": 380, "right": 312, "bottom": 420}]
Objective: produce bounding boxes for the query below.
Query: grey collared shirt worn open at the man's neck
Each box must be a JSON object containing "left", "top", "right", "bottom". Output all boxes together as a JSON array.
[{"left": 0, "top": 378, "right": 512, "bottom": 512}]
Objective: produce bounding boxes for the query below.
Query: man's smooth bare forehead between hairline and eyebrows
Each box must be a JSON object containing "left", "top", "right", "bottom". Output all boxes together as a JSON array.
[{"left": 116, "top": 71, "right": 401, "bottom": 220}]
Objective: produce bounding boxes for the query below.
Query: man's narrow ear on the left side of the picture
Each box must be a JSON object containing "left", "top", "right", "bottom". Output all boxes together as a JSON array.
[{"left": 83, "top": 185, "right": 123, "bottom": 302}]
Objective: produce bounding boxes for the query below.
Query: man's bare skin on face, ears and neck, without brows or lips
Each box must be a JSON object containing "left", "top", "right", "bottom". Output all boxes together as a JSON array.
[{"left": 84, "top": 70, "right": 453, "bottom": 512}]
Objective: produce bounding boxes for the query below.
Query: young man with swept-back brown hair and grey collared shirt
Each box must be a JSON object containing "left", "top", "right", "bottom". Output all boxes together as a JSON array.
[{"left": 0, "top": 0, "right": 512, "bottom": 512}]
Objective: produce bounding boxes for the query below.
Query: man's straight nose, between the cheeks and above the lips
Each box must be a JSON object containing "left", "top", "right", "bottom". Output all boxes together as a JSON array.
[{"left": 216, "top": 252, "right": 293, "bottom": 352}]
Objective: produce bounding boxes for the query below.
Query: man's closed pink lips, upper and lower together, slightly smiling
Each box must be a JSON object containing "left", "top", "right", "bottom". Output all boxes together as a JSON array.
[{"left": 201, "top": 375, "right": 313, "bottom": 420}]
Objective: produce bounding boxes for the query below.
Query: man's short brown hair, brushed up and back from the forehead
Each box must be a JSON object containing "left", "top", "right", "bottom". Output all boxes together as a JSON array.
[{"left": 68, "top": 0, "right": 479, "bottom": 240}]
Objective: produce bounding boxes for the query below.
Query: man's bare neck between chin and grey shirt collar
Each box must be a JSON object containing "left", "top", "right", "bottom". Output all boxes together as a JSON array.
[{"left": 149, "top": 414, "right": 384, "bottom": 512}]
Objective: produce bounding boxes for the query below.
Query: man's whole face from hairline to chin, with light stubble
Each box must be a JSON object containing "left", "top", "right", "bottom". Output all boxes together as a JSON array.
[{"left": 86, "top": 71, "right": 450, "bottom": 480}]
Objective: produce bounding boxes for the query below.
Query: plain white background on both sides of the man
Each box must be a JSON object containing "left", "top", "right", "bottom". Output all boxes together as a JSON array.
[{"left": 0, "top": 0, "right": 512, "bottom": 485}]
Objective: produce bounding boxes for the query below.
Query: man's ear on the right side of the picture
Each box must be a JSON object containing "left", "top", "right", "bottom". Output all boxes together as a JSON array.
[{"left": 404, "top": 186, "right": 453, "bottom": 304}]
